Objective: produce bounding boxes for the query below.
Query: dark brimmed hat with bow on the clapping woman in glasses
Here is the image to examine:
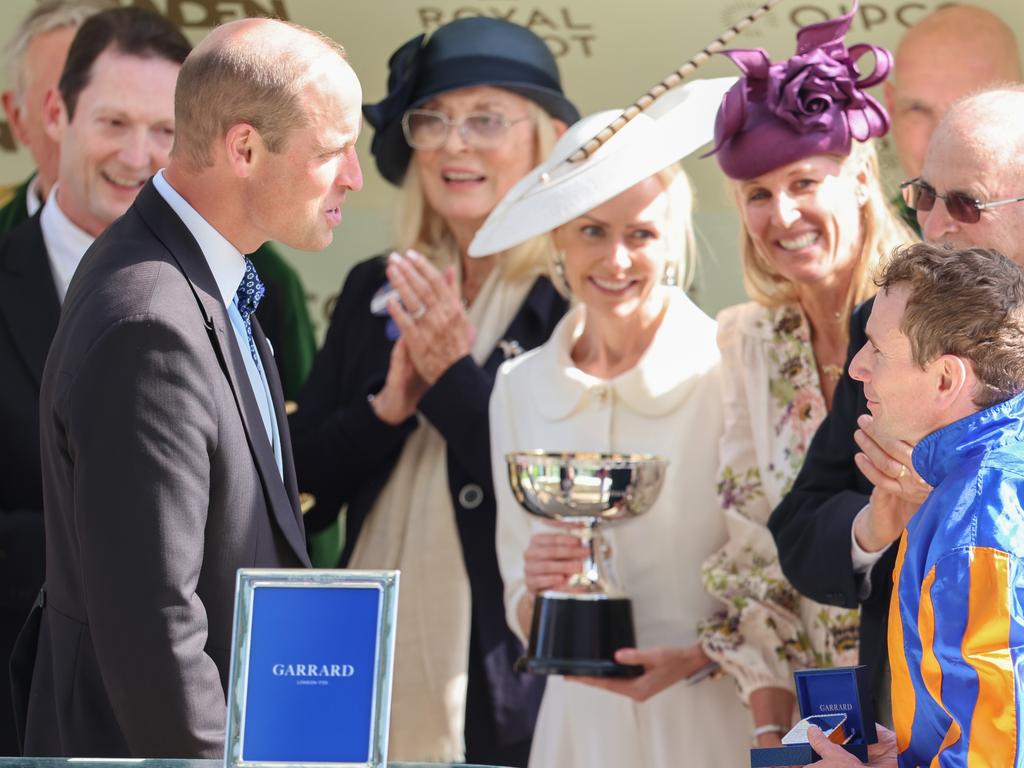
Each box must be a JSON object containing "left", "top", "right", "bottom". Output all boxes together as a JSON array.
[{"left": 362, "top": 16, "right": 580, "bottom": 184}]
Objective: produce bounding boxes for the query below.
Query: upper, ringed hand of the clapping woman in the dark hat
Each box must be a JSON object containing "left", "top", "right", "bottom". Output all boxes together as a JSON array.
[{"left": 387, "top": 251, "right": 476, "bottom": 386}]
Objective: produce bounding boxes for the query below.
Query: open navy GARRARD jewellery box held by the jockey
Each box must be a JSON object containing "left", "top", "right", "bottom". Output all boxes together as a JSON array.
[{"left": 751, "top": 665, "right": 879, "bottom": 768}]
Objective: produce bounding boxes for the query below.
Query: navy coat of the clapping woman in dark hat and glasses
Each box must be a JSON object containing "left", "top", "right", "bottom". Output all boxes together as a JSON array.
[{"left": 291, "top": 256, "right": 566, "bottom": 766}]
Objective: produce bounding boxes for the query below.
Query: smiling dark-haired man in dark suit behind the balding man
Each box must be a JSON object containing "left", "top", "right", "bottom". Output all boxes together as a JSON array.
[{"left": 0, "top": 3, "right": 191, "bottom": 755}]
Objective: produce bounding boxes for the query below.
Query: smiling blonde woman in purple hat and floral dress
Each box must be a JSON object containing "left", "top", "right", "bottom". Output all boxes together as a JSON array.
[{"left": 701, "top": 2, "right": 914, "bottom": 746}]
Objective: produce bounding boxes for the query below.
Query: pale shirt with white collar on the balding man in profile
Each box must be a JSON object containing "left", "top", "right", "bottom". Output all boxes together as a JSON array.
[{"left": 153, "top": 170, "right": 284, "bottom": 477}]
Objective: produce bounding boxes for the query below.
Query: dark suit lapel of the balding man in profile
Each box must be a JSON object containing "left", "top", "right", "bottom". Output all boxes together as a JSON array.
[{"left": 134, "top": 181, "right": 309, "bottom": 564}]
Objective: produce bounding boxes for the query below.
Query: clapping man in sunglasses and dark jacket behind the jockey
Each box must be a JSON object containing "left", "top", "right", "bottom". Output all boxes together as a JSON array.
[{"left": 768, "top": 86, "right": 1024, "bottom": 723}]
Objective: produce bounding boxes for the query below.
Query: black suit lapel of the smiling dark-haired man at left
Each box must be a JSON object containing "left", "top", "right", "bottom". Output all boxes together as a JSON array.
[{"left": 0, "top": 215, "right": 60, "bottom": 388}]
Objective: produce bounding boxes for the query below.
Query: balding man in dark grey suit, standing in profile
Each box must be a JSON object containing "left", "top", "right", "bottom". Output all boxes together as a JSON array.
[{"left": 16, "top": 19, "right": 362, "bottom": 758}]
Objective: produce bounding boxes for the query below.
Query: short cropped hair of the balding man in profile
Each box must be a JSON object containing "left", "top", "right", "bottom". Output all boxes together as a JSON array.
[{"left": 171, "top": 22, "right": 347, "bottom": 169}]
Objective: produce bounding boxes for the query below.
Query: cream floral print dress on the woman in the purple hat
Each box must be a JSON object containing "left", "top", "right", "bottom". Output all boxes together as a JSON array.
[{"left": 700, "top": 303, "right": 858, "bottom": 701}]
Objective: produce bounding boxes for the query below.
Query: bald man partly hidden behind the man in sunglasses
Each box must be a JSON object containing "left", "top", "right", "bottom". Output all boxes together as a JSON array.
[{"left": 885, "top": 5, "right": 1021, "bottom": 178}]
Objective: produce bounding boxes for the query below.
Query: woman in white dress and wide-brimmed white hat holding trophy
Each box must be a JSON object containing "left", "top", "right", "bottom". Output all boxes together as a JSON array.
[{"left": 470, "top": 80, "right": 750, "bottom": 768}]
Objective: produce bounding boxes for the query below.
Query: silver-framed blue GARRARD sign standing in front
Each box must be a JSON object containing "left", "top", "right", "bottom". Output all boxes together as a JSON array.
[{"left": 224, "top": 569, "right": 398, "bottom": 768}]
